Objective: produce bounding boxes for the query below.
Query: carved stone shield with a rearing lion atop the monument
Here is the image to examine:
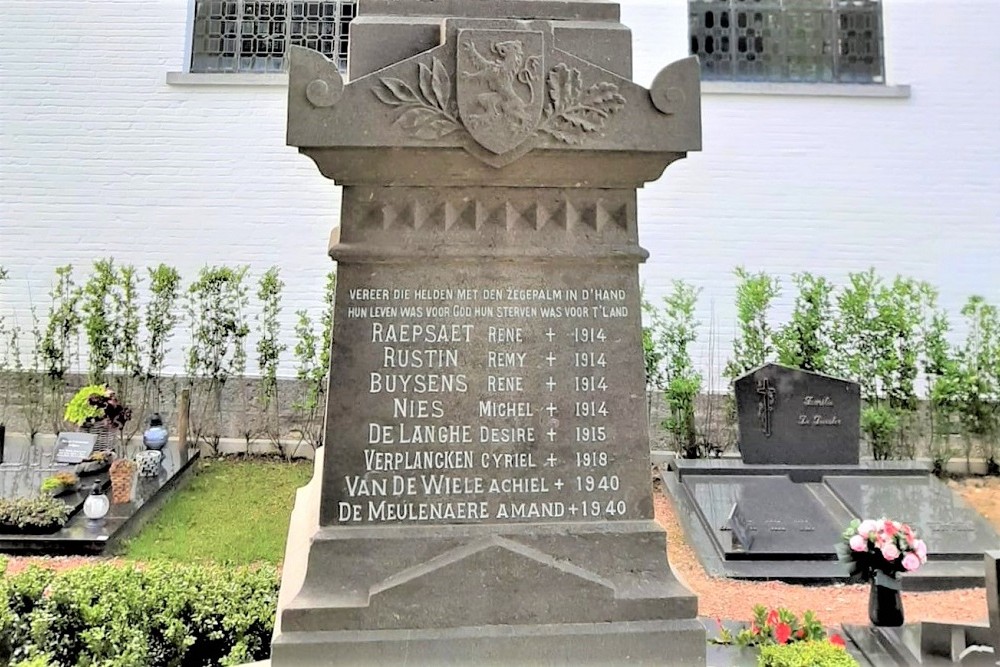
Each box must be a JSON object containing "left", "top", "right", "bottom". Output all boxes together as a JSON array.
[{"left": 455, "top": 30, "right": 545, "bottom": 155}]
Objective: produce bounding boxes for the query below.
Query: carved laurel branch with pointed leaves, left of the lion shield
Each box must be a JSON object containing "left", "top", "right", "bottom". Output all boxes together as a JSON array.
[{"left": 373, "top": 58, "right": 462, "bottom": 139}]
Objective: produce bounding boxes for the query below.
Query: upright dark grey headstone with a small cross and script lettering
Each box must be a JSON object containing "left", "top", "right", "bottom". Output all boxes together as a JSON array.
[{"left": 735, "top": 364, "right": 861, "bottom": 465}]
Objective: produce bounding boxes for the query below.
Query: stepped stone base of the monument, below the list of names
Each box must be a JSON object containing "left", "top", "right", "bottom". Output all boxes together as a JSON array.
[{"left": 271, "top": 448, "right": 705, "bottom": 667}]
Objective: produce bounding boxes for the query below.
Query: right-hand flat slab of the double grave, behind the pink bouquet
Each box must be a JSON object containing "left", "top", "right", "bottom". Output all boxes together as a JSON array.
[{"left": 825, "top": 475, "right": 1000, "bottom": 561}]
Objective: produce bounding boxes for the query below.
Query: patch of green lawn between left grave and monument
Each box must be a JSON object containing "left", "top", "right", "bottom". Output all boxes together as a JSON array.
[{"left": 123, "top": 459, "right": 313, "bottom": 564}]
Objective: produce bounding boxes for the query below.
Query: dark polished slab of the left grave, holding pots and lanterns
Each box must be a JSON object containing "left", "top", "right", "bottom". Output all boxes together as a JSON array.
[{"left": 0, "top": 443, "right": 199, "bottom": 554}]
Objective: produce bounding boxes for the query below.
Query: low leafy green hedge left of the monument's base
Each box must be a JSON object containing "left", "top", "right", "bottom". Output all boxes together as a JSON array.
[{"left": 0, "top": 563, "right": 279, "bottom": 667}]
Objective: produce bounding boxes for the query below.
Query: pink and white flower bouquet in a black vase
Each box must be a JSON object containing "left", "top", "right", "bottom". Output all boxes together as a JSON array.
[{"left": 837, "top": 517, "right": 927, "bottom": 627}]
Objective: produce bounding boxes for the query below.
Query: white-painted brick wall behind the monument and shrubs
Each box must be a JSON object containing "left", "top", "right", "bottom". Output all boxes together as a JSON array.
[{"left": 0, "top": 0, "right": 1000, "bottom": 384}]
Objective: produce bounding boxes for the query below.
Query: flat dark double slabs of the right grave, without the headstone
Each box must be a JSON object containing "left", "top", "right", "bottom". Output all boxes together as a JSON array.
[{"left": 664, "top": 460, "right": 1000, "bottom": 590}]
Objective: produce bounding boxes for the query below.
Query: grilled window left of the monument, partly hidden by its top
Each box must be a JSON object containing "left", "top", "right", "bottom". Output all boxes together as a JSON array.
[{"left": 191, "top": 0, "right": 356, "bottom": 72}]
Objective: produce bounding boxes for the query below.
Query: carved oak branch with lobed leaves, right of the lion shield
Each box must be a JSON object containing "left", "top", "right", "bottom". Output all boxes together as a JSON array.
[{"left": 538, "top": 64, "right": 625, "bottom": 144}]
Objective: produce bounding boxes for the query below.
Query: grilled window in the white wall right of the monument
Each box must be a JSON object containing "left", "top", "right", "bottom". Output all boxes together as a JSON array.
[{"left": 688, "top": 0, "right": 885, "bottom": 83}]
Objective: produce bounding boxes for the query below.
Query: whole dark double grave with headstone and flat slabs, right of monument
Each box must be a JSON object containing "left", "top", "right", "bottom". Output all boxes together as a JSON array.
[{"left": 664, "top": 364, "right": 1000, "bottom": 590}]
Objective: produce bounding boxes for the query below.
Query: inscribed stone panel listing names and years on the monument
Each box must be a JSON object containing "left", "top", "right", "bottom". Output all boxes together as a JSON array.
[{"left": 326, "top": 268, "right": 651, "bottom": 525}]
